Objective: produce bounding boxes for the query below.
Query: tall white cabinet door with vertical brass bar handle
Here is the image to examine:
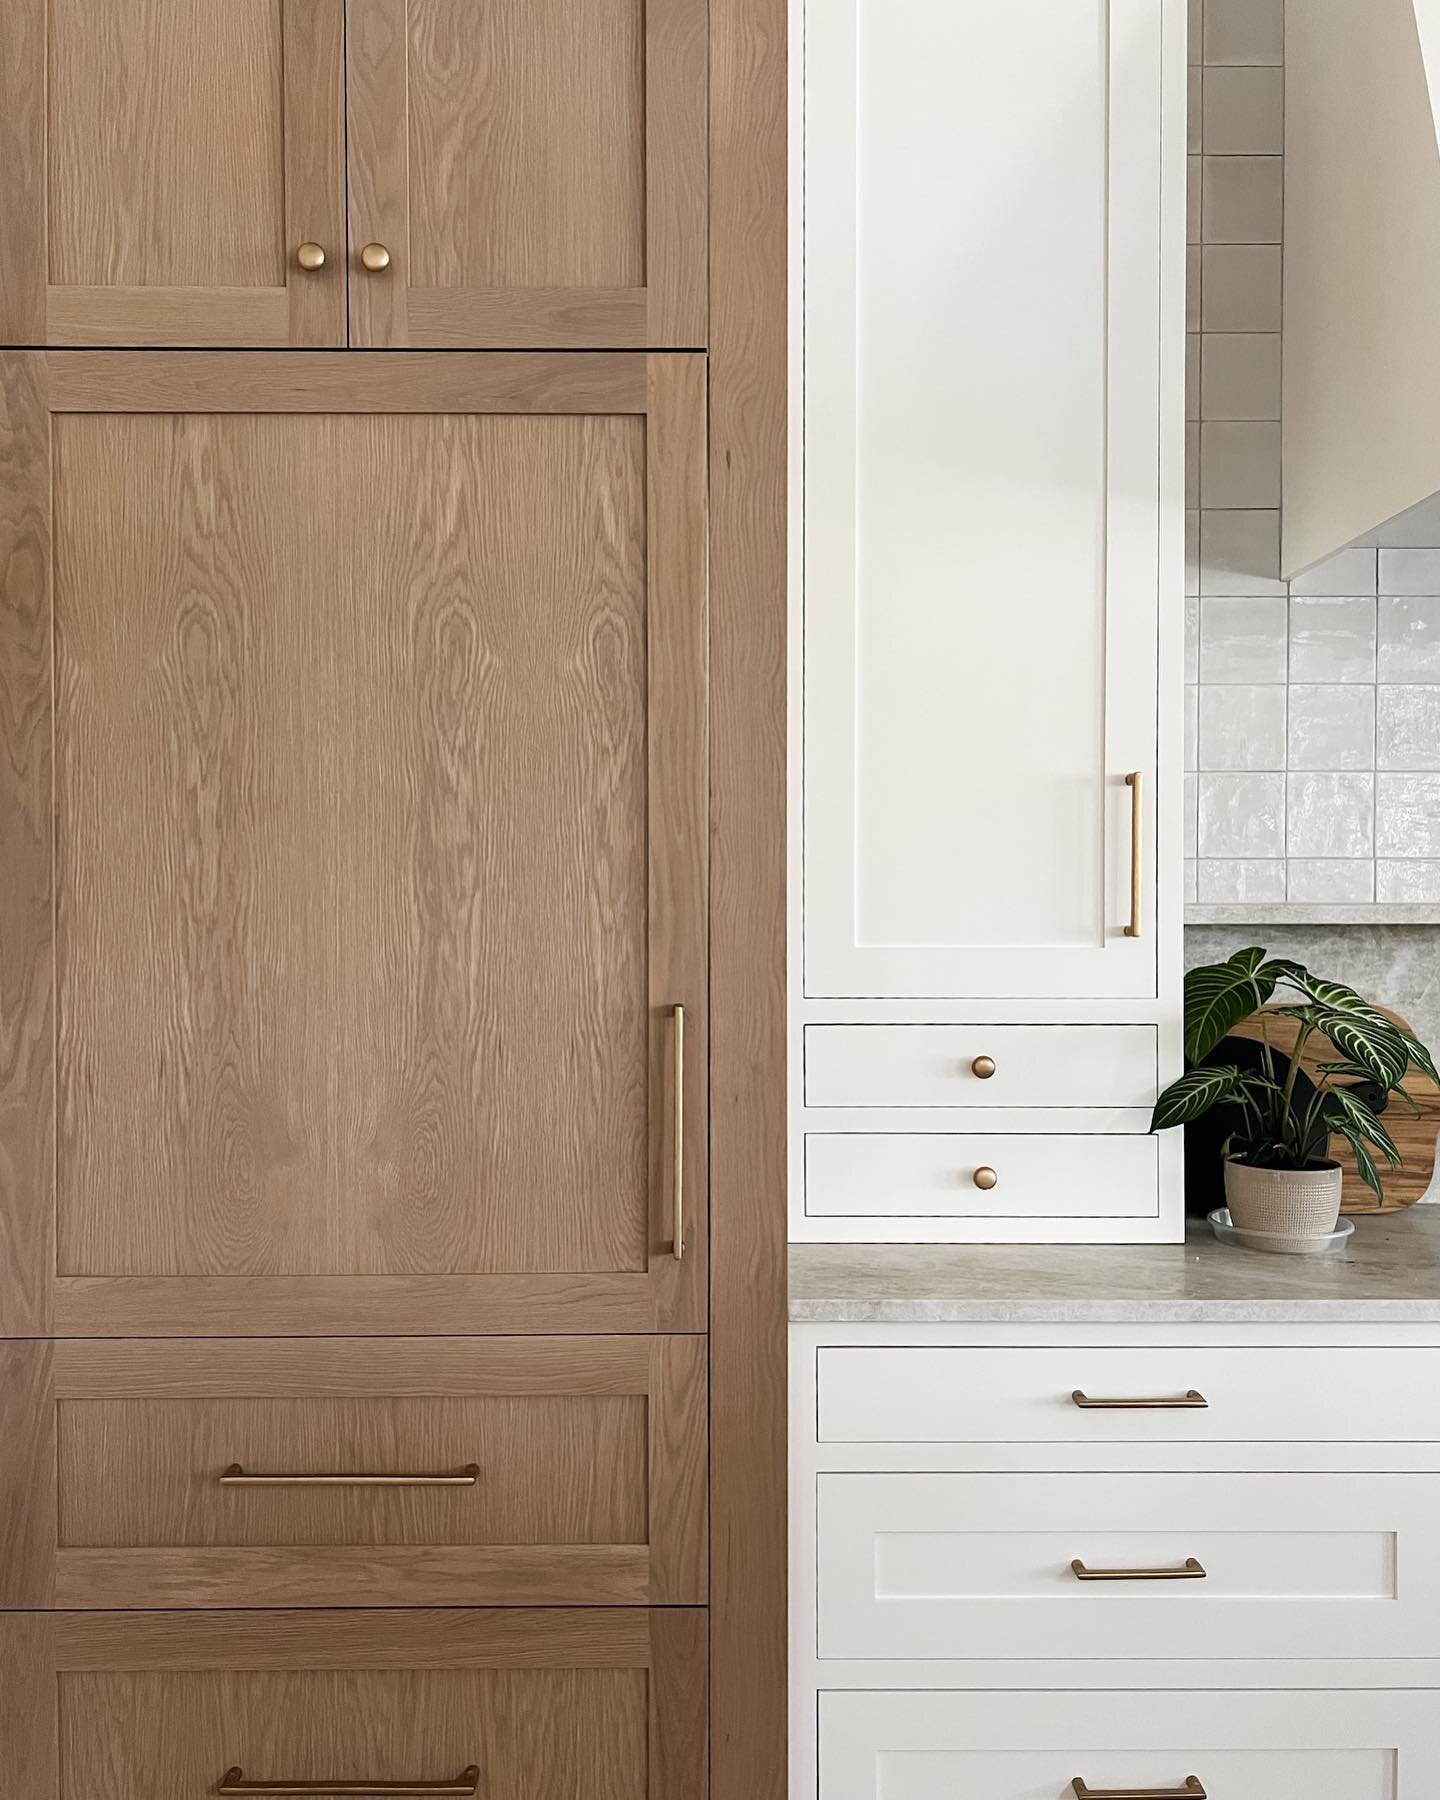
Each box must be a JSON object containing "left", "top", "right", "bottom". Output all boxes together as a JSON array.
[{"left": 803, "top": 0, "right": 1184, "bottom": 1001}]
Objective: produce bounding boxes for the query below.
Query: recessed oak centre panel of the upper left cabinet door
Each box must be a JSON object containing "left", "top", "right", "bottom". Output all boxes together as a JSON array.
[{"left": 47, "top": 0, "right": 284, "bottom": 288}]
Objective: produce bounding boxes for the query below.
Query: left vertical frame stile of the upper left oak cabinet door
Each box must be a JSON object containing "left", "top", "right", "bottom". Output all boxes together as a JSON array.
[{"left": 0, "top": 0, "right": 49, "bottom": 344}]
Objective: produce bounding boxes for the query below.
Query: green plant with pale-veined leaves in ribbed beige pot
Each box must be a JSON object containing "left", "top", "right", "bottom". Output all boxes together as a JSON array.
[{"left": 1150, "top": 949, "right": 1436, "bottom": 1237}]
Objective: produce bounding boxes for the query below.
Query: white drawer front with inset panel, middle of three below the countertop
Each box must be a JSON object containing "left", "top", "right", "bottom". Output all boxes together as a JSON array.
[{"left": 817, "top": 1474, "right": 1440, "bottom": 1660}]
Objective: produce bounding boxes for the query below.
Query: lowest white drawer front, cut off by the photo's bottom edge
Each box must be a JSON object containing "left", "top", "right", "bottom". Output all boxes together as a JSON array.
[{"left": 819, "top": 1692, "right": 1440, "bottom": 1800}]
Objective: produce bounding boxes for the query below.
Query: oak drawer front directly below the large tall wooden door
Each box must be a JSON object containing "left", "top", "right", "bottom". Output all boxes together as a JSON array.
[{"left": 0, "top": 1337, "right": 706, "bottom": 1607}]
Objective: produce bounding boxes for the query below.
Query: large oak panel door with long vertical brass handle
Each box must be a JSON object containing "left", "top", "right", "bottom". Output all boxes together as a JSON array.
[{"left": 0, "top": 351, "right": 707, "bottom": 1336}]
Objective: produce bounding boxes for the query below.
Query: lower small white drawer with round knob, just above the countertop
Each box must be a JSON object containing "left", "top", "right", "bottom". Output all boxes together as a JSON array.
[{"left": 805, "top": 1132, "right": 1159, "bottom": 1220}]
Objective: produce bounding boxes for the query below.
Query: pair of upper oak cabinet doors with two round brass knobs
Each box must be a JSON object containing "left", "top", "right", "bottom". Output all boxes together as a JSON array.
[{"left": 0, "top": 0, "right": 707, "bottom": 349}]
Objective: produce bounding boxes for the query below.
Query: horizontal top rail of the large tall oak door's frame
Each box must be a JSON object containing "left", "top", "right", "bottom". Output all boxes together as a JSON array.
[{"left": 47, "top": 351, "right": 648, "bottom": 412}]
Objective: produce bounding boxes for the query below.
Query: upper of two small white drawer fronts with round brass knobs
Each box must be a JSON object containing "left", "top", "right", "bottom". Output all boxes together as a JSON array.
[{"left": 805, "top": 1024, "right": 1157, "bottom": 1112}]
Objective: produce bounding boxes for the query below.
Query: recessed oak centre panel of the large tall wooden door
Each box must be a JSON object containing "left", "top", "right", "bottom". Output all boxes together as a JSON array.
[{"left": 56, "top": 416, "right": 648, "bottom": 1276}]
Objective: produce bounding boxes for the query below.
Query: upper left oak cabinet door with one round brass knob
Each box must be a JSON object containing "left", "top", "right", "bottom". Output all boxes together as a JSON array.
[{"left": 0, "top": 0, "right": 346, "bottom": 346}]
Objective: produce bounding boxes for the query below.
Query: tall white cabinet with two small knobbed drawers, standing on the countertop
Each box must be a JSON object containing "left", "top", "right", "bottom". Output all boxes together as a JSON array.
[{"left": 790, "top": 0, "right": 1186, "bottom": 1242}]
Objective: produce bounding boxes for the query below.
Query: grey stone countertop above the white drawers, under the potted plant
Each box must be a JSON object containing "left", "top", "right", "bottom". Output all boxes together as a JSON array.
[{"left": 790, "top": 1206, "right": 1440, "bottom": 1325}]
